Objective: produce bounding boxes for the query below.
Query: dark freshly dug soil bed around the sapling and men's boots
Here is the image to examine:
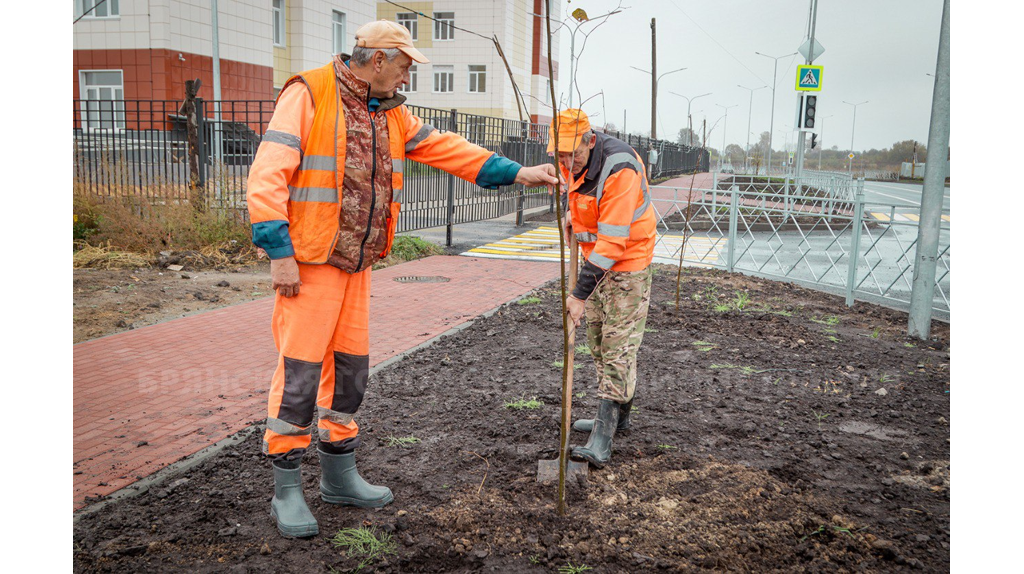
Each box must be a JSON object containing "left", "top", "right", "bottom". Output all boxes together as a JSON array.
[{"left": 74, "top": 267, "right": 949, "bottom": 573}]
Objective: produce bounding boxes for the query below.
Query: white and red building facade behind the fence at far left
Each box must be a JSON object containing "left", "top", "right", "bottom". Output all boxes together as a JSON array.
[{"left": 73, "top": 0, "right": 376, "bottom": 100}]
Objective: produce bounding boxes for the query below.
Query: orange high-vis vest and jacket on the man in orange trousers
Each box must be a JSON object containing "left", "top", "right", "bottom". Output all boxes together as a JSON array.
[{"left": 247, "top": 60, "right": 493, "bottom": 272}]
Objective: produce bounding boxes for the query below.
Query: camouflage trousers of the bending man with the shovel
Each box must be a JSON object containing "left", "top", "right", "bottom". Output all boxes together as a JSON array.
[{"left": 585, "top": 267, "right": 653, "bottom": 403}]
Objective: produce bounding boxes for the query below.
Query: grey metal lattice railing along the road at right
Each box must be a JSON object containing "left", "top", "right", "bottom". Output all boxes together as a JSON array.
[{"left": 651, "top": 180, "right": 950, "bottom": 320}]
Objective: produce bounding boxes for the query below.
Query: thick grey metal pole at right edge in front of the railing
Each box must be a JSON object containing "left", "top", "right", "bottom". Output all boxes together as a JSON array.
[{"left": 908, "top": 0, "right": 949, "bottom": 340}]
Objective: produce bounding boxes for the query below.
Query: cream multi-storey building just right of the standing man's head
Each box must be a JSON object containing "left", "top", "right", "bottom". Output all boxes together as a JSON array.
[{"left": 377, "top": 0, "right": 561, "bottom": 122}]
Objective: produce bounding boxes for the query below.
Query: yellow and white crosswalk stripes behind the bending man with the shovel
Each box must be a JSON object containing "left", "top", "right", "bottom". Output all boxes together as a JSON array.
[{"left": 460, "top": 227, "right": 727, "bottom": 267}]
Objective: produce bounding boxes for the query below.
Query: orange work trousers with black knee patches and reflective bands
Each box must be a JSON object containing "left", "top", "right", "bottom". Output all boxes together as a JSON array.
[{"left": 263, "top": 263, "right": 370, "bottom": 459}]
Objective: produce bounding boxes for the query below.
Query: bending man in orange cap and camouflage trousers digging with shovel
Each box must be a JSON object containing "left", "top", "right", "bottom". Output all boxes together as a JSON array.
[{"left": 548, "top": 109, "right": 656, "bottom": 468}]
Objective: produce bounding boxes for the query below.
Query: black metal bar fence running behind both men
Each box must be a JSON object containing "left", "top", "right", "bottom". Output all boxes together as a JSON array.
[{"left": 74, "top": 98, "right": 709, "bottom": 238}]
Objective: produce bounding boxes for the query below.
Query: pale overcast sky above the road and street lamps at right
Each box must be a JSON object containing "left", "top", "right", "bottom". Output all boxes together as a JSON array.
[{"left": 560, "top": 0, "right": 942, "bottom": 151}]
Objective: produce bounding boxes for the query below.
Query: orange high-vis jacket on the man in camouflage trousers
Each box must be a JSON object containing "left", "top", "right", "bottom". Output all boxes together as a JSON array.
[{"left": 559, "top": 132, "right": 657, "bottom": 271}]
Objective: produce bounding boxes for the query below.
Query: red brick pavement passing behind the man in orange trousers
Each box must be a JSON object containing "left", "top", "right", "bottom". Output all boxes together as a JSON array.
[{"left": 74, "top": 256, "right": 558, "bottom": 510}]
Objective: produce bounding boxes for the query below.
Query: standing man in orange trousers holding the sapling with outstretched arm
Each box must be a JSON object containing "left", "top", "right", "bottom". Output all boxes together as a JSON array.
[{"left": 248, "top": 20, "right": 557, "bottom": 537}]
